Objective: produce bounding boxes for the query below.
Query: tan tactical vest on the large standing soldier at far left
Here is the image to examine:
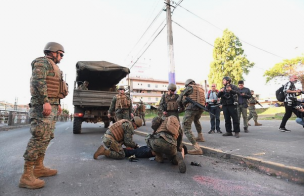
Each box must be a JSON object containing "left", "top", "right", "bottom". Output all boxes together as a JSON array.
[{"left": 46, "top": 58, "right": 68, "bottom": 99}]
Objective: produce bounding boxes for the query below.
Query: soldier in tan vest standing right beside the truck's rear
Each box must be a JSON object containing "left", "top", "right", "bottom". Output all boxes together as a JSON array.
[{"left": 108, "top": 86, "right": 134, "bottom": 121}]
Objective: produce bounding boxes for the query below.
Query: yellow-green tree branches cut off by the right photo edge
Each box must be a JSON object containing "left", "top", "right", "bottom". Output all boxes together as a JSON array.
[{"left": 264, "top": 56, "right": 304, "bottom": 90}]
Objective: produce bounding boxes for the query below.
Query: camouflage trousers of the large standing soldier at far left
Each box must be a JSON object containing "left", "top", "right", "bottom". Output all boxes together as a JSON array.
[{"left": 23, "top": 105, "right": 58, "bottom": 161}]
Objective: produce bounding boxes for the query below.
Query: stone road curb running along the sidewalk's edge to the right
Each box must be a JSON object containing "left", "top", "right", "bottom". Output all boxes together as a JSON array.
[{"left": 135, "top": 130, "right": 304, "bottom": 185}]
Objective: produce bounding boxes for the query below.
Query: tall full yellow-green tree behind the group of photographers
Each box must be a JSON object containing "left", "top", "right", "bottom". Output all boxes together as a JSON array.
[{"left": 208, "top": 29, "right": 254, "bottom": 87}]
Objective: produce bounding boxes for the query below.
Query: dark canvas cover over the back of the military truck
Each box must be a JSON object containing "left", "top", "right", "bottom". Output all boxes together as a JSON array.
[{"left": 76, "top": 61, "right": 130, "bottom": 90}]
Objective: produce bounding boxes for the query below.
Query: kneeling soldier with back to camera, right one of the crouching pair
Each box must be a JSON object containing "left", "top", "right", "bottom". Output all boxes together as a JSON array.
[{"left": 146, "top": 116, "right": 186, "bottom": 173}]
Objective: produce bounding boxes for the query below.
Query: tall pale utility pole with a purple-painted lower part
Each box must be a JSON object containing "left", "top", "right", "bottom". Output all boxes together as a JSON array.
[{"left": 166, "top": 0, "right": 176, "bottom": 84}]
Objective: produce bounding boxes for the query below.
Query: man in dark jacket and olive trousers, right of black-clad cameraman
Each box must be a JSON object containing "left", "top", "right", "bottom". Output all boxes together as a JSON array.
[{"left": 237, "top": 80, "right": 251, "bottom": 133}]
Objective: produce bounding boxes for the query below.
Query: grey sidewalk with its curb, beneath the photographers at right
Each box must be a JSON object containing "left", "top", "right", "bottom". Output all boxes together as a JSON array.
[{"left": 135, "top": 118, "right": 304, "bottom": 184}]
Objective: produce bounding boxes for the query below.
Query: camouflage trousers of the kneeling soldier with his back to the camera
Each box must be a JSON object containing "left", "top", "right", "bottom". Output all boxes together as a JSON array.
[{"left": 146, "top": 134, "right": 177, "bottom": 160}]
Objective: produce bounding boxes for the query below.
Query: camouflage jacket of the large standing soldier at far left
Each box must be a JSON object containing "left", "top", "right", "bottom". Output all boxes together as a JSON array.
[{"left": 30, "top": 57, "right": 62, "bottom": 106}]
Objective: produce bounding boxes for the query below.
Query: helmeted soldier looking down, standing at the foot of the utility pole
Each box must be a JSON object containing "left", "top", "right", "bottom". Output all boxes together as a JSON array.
[{"left": 159, "top": 83, "right": 179, "bottom": 120}]
